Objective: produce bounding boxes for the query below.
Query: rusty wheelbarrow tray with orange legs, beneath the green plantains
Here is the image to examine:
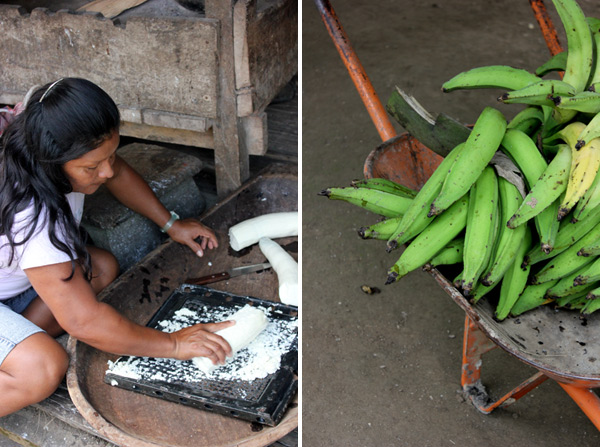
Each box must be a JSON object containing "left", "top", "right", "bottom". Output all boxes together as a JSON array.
[{"left": 364, "top": 133, "right": 600, "bottom": 429}]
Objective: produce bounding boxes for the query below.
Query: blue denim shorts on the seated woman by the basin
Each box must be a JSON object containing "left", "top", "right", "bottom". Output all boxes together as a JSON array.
[{"left": 0, "top": 288, "right": 43, "bottom": 365}]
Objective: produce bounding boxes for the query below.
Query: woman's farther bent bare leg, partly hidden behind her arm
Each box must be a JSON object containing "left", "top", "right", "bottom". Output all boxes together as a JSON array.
[{"left": 23, "top": 247, "right": 119, "bottom": 337}]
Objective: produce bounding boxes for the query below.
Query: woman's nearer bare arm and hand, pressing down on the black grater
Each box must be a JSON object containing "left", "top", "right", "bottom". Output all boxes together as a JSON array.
[{"left": 25, "top": 262, "right": 234, "bottom": 363}]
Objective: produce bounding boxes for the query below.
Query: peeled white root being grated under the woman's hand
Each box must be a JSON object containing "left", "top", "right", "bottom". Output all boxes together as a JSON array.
[{"left": 192, "top": 304, "right": 268, "bottom": 374}]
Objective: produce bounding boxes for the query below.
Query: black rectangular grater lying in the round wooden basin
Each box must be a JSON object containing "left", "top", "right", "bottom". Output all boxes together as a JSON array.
[{"left": 104, "top": 284, "right": 298, "bottom": 426}]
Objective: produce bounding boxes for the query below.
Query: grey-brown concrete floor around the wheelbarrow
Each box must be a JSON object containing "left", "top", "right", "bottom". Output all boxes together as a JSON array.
[{"left": 301, "top": 0, "right": 600, "bottom": 447}]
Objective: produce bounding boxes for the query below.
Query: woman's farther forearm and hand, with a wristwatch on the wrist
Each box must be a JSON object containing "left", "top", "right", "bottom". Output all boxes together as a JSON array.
[{"left": 106, "top": 156, "right": 219, "bottom": 256}]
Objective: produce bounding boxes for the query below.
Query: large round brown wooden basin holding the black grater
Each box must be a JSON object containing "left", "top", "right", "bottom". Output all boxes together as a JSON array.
[{"left": 67, "top": 164, "right": 298, "bottom": 447}]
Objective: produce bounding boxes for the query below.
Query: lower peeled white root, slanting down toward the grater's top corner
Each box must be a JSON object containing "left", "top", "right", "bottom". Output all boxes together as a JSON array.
[{"left": 258, "top": 237, "right": 298, "bottom": 306}]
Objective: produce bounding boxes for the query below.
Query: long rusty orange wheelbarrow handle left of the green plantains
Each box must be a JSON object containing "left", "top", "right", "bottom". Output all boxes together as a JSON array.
[{"left": 315, "top": 0, "right": 397, "bottom": 141}]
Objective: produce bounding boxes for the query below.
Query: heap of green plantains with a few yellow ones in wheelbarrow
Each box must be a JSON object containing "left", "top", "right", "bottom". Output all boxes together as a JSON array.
[{"left": 321, "top": 0, "right": 600, "bottom": 320}]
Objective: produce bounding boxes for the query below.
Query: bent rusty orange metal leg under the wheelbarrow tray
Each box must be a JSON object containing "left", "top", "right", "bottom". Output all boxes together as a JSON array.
[{"left": 461, "top": 316, "right": 548, "bottom": 414}]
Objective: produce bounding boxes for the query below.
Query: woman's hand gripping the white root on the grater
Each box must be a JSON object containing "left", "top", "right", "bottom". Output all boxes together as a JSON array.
[{"left": 170, "top": 320, "right": 235, "bottom": 365}]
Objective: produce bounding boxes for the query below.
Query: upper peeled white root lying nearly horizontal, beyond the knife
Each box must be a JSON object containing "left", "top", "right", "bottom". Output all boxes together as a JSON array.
[{"left": 229, "top": 211, "right": 298, "bottom": 251}]
